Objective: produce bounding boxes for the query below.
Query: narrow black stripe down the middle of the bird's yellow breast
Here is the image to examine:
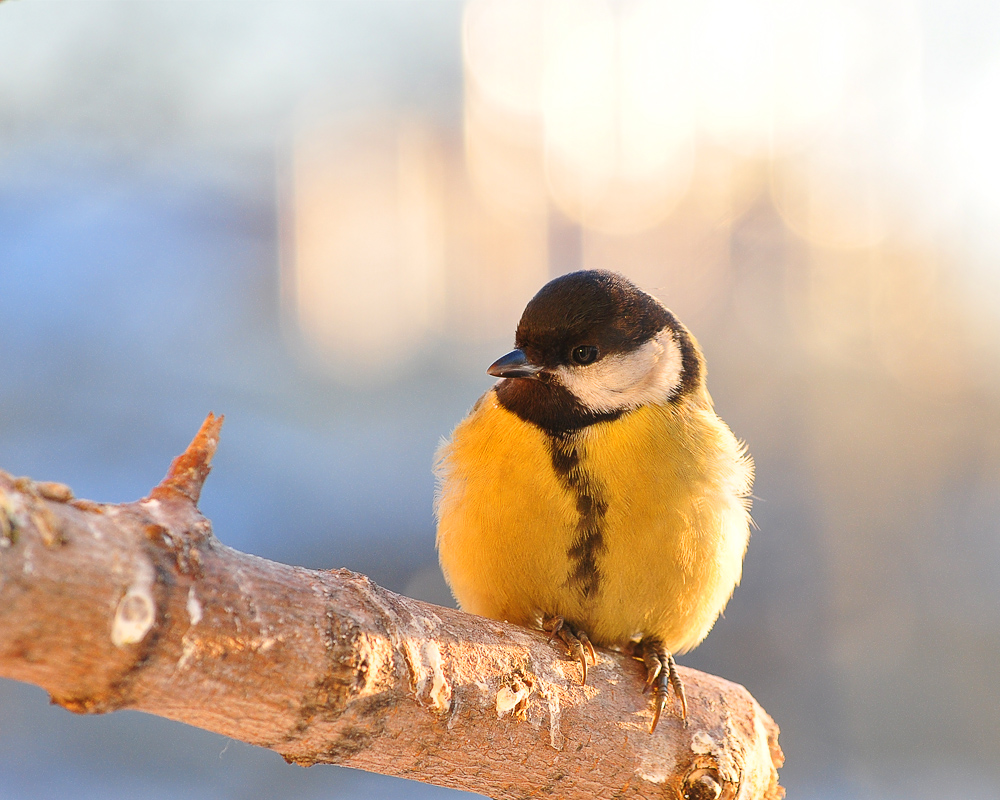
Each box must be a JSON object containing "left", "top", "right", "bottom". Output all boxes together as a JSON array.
[{"left": 549, "top": 435, "right": 608, "bottom": 597}]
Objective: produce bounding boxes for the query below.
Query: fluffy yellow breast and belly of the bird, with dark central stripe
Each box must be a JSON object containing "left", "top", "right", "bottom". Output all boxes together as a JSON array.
[{"left": 437, "top": 391, "right": 753, "bottom": 652}]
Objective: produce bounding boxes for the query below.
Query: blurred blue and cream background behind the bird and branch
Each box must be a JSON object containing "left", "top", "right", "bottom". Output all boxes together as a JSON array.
[{"left": 0, "top": 0, "right": 1000, "bottom": 800}]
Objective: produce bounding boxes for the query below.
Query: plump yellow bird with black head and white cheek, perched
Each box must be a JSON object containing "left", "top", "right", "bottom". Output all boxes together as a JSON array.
[{"left": 435, "top": 270, "right": 754, "bottom": 733}]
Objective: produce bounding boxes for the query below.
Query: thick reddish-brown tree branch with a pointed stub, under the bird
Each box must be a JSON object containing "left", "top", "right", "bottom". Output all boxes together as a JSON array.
[{"left": 0, "top": 415, "right": 783, "bottom": 800}]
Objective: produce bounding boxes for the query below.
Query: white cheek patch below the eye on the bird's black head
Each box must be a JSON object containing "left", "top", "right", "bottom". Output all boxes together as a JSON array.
[{"left": 552, "top": 328, "right": 683, "bottom": 412}]
